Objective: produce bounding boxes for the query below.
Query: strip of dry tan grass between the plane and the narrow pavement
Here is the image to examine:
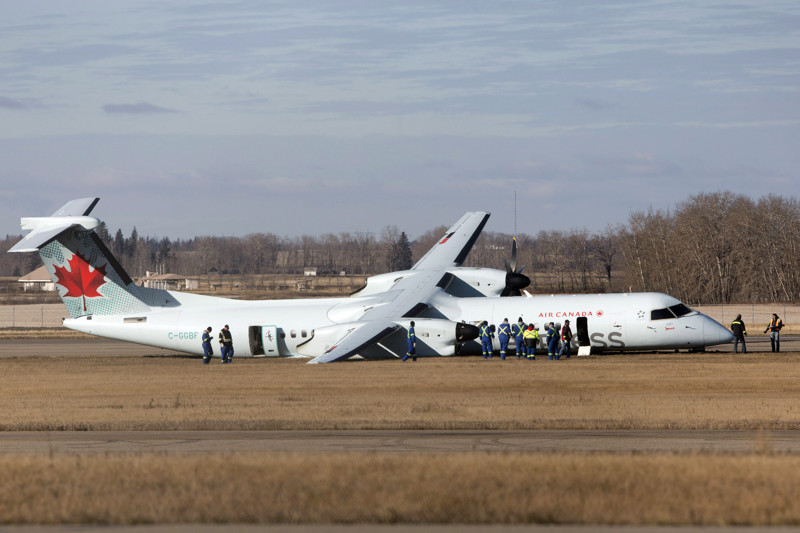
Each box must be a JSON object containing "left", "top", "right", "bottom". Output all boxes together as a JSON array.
[{"left": 0, "top": 352, "right": 800, "bottom": 431}]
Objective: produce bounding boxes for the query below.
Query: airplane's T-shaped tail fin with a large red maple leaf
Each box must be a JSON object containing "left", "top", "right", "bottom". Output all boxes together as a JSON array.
[{"left": 9, "top": 198, "right": 149, "bottom": 318}]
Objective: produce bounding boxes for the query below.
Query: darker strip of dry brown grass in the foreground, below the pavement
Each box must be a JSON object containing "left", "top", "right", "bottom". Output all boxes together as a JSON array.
[{"left": 0, "top": 452, "right": 800, "bottom": 525}]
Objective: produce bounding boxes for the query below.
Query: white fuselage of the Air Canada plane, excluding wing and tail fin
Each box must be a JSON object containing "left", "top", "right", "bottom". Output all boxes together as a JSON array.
[{"left": 64, "top": 286, "right": 732, "bottom": 357}]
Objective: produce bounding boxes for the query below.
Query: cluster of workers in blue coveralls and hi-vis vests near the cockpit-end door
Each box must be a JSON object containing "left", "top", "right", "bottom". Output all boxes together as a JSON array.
[{"left": 478, "top": 317, "right": 572, "bottom": 361}]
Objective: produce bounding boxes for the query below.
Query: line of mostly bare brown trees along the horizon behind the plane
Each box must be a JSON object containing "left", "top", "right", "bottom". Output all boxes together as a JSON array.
[{"left": 0, "top": 192, "right": 800, "bottom": 304}]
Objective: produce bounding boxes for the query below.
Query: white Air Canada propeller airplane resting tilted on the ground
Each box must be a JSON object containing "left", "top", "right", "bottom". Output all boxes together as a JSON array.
[{"left": 9, "top": 198, "right": 733, "bottom": 364}]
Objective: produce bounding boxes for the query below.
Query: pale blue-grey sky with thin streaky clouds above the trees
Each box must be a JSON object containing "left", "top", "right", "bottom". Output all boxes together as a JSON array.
[{"left": 0, "top": 0, "right": 800, "bottom": 239}]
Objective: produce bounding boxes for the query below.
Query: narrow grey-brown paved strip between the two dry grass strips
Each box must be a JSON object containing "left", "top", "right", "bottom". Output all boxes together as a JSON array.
[{"left": 0, "top": 430, "right": 800, "bottom": 454}]
